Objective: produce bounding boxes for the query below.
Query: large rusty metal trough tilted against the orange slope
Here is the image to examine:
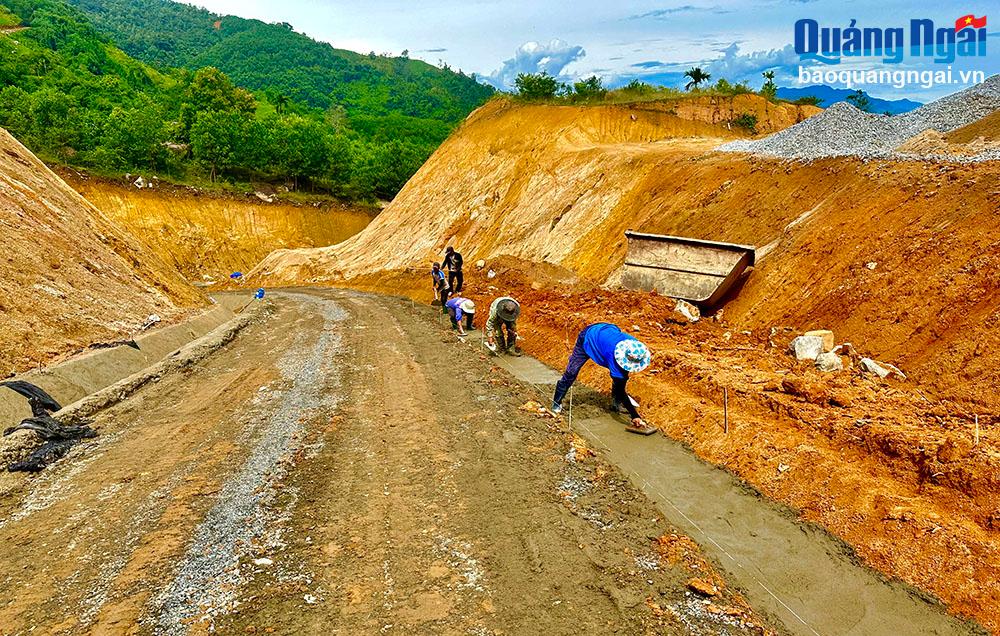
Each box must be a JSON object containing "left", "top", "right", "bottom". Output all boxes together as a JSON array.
[{"left": 622, "top": 230, "right": 756, "bottom": 307}]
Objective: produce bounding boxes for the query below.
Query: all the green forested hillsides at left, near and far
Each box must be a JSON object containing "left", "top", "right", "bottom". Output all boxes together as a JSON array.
[{"left": 0, "top": 0, "right": 490, "bottom": 199}]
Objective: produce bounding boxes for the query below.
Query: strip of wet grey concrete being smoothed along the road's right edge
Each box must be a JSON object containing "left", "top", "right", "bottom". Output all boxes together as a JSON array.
[{"left": 469, "top": 332, "right": 986, "bottom": 636}]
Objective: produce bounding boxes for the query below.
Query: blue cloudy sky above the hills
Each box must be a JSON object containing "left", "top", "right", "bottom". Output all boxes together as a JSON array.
[{"left": 184, "top": 0, "right": 1000, "bottom": 101}]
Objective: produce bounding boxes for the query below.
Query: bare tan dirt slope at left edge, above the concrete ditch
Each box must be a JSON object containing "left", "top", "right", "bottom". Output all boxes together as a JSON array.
[{"left": 0, "top": 129, "right": 207, "bottom": 377}]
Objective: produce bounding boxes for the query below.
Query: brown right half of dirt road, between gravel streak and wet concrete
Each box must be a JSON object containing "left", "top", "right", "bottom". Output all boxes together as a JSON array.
[{"left": 217, "top": 291, "right": 763, "bottom": 635}]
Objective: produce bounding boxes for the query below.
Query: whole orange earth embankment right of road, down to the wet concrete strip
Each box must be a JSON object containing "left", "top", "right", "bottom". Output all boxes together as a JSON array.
[{"left": 255, "top": 95, "right": 1000, "bottom": 631}]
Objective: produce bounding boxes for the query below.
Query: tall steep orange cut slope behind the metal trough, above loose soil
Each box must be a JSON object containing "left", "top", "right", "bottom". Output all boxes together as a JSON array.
[{"left": 258, "top": 96, "right": 1000, "bottom": 400}]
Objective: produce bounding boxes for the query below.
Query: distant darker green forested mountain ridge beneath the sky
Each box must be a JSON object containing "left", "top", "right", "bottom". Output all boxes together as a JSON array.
[{"left": 62, "top": 0, "right": 493, "bottom": 123}]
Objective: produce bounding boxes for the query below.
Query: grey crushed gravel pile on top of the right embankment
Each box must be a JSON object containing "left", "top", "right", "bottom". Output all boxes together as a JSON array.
[{"left": 718, "top": 75, "right": 1000, "bottom": 162}]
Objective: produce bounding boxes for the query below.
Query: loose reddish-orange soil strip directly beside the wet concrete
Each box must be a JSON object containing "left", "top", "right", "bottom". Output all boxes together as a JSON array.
[{"left": 322, "top": 259, "right": 1000, "bottom": 633}]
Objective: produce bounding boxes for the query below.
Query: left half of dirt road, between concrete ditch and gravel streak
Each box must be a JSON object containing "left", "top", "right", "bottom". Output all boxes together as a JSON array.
[{"left": 0, "top": 296, "right": 340, "bottom": 634}]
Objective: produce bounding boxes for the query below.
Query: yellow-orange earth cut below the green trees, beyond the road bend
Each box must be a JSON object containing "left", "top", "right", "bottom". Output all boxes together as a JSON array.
[{"left": 67, "top": 174, "right": 376, "bottom": 282}]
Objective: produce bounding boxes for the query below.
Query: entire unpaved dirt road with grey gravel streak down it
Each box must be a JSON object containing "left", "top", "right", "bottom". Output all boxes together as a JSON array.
[{"left": 0, "top": 291, "right": 771, "bottom": 635}]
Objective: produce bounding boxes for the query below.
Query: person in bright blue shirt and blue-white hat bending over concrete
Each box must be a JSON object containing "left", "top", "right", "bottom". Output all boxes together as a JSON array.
[{"left": 552, "top": 322, "right": 656, "bottom": 435}]
